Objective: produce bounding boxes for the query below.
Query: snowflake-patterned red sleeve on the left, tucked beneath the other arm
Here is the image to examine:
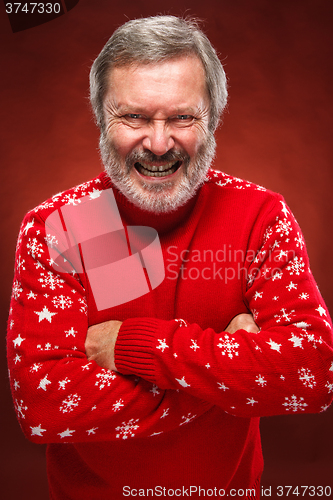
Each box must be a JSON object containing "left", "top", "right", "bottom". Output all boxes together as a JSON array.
[{"left": 7, "top": 212, "right": 211, "bottom": 443}]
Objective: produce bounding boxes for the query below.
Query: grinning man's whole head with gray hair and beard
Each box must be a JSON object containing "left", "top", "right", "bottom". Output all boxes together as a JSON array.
[{"left": 90, "top": 16, "right": 227, "bottom": 212}]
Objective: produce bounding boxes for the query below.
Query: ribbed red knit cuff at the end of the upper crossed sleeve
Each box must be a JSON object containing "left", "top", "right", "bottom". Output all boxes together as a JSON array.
[{"left": 115, "top": 318, "right": 161, "bottom": 383}]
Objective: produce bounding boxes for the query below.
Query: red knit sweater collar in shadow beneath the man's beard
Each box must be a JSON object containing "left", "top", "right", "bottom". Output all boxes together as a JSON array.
[{"left": 100, "top": 172, "right": 200, "bottom": 234}]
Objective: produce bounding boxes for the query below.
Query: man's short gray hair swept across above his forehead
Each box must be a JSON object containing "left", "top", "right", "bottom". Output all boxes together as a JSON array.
[{"left": 90, "top": 16, "right": 228, "bottom": 133}]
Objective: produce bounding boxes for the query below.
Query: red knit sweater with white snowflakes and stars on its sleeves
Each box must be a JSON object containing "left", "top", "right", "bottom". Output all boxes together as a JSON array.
[{"left": 8, "top": 170, "right": 333, "bottom": 500}]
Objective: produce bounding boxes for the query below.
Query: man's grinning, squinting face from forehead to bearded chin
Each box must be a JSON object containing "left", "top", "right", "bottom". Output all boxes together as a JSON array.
[{"left": 101, "top": 56, "right": 215, "bottom": 212}]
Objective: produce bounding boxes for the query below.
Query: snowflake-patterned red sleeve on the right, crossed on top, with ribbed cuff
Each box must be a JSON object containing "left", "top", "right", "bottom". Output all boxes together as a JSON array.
[{"left": 115, "top": 198, "right": 333, "bottom": 417}]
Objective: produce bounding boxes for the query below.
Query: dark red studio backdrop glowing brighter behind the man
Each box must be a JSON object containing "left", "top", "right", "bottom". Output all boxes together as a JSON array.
[{"left": 0, "top": 0, "right": 333, "bottom": 500}]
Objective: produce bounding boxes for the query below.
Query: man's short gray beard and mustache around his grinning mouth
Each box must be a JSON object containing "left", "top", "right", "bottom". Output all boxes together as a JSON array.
[{"left": 99, "top": 132, "right": 216, "bottom": 213}]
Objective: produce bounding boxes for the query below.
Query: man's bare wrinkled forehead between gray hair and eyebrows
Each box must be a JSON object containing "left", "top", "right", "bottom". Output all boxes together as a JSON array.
[{"left": 106, "top": 55, "right": 208, "bottom": 110}]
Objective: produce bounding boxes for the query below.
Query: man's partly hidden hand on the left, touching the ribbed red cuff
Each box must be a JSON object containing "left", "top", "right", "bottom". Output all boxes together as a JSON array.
[{"left": 85, "top": 321, "right": 122, "bottom": 371}]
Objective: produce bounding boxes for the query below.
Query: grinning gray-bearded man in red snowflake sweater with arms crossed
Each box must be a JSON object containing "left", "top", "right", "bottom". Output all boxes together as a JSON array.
[{"left": 8, "top": 16, "right": 333, "bottom": 499}]
